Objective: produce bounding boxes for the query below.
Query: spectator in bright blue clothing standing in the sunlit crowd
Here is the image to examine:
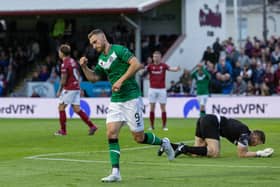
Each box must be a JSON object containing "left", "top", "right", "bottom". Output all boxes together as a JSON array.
[{"left": 216, "top": 56, "right": 232, "bottom": 94}]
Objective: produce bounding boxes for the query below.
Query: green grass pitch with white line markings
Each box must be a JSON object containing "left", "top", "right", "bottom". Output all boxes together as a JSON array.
[{"left": 0, "top": 119, "right": 280, "bottom": 187}]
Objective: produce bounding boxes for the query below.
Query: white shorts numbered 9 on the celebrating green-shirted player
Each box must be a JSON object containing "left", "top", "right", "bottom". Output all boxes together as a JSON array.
[{"left": 106, "top": 97, "right": 144, "bottom": 132}]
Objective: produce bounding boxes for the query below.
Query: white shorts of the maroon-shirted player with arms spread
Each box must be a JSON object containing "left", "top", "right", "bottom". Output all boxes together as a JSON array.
[{"left": 148, "top": 88, "right": 167, "bottom": 104}]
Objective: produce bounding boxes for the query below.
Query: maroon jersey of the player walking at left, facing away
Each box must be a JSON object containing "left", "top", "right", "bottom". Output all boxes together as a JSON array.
[{"left": 61, "top": 58, "right": 80, "bottom": 90}]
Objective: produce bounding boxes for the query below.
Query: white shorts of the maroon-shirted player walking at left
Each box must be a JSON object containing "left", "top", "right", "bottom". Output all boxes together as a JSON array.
[{"left": 58, "top": 90, "right": 80, "bottom": 105}]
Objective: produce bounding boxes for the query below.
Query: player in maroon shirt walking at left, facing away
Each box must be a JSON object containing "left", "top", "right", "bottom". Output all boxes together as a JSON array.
[{"left": 55, "top": 44, "right": 97, "bottom": 135}]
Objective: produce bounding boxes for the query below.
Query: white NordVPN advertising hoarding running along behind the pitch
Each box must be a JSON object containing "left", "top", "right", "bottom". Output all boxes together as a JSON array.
[{"left": 0, "top": 96, "right": 280, "bottom": 118}]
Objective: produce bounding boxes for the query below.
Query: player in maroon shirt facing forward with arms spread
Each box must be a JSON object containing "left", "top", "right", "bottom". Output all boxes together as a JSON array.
[{"left": 145, "top": 51, "right": 180, "bottom": 131}]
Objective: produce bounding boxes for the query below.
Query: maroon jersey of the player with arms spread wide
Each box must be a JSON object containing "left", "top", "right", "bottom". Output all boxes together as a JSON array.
[{"left": 147, "top": 62, "right": 169, "bottom": 88}]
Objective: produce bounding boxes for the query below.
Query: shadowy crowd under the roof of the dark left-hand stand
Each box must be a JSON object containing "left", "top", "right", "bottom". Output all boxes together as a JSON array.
[{"left": 0, "top": 22, "right": 177, "bottom": 97}]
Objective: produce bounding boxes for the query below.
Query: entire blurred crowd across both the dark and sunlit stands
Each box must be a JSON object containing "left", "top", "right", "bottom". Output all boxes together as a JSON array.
[{"left": 0, "top": 23, "right": 280, "bottom": 96}]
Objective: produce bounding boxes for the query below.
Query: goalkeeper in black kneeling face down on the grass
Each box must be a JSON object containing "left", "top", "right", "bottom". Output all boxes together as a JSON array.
[{"left": 158, "top": 114, "right": 274, "bottom": 158}]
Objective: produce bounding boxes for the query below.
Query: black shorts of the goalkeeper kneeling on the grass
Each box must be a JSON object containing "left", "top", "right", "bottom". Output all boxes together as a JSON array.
[{"left": 195, "top": 115, "right": 220, "bottom": 140}]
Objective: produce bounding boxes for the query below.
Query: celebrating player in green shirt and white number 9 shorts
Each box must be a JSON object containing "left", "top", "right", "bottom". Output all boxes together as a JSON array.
[{"left": 80, "top": 29, "right": 174, "bottom": 182}]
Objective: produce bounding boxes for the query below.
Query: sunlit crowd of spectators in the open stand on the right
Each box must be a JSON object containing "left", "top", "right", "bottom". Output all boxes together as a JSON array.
[{"left": 168, "top": 36, "right": 280, "bottom": 96}]
